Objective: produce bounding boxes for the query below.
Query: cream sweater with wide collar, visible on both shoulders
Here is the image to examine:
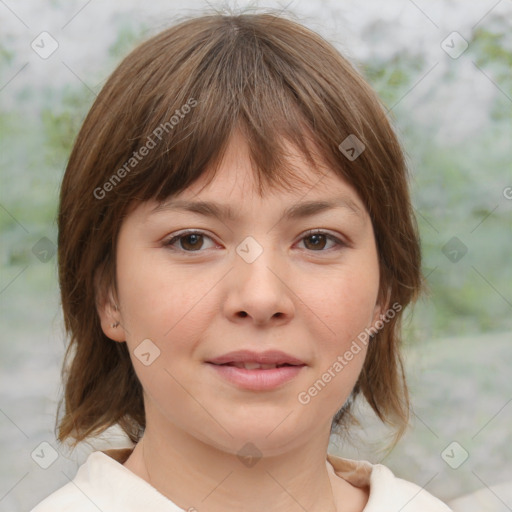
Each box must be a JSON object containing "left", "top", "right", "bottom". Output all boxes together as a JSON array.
[{"left": 31, "top": 448, "right": 450, "bottom": 512}]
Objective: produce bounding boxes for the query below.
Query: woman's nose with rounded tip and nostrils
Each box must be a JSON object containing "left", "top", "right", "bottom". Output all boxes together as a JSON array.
[{"left": 224, "top": 241, "right": 295, "bottom": 326}]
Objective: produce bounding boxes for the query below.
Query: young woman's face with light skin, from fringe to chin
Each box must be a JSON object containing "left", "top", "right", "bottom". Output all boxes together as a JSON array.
[{"left": 100, "top": 131, "right": 381, "bottom": 454}]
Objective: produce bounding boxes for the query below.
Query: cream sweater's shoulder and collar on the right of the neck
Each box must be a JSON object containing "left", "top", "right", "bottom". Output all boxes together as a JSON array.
[{"left": 327, "top": 455, "right": 451, "bottom": 512}]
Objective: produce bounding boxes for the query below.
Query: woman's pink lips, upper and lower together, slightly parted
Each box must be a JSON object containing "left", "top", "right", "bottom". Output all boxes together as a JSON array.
[{"left": 207, "top": 350, "right": 306, "bottom": 391}]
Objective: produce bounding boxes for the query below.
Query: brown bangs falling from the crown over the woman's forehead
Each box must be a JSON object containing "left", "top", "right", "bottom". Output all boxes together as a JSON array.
[{"left": 105, "top": 16, "right": 364, "bottom": 210}]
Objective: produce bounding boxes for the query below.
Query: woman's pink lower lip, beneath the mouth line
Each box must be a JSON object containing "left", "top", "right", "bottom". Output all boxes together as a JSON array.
[{"left": 208, "top": 363, "right": 305, "bottom": 391}]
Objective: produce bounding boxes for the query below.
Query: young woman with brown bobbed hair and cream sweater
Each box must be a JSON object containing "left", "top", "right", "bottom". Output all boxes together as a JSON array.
[{"left": 30, "top": 9, "right": 449, "bottom": 512}]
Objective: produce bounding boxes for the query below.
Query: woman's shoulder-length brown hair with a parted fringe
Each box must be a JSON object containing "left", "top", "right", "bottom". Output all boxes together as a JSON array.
[{"left": 57, "top": 13, "right": 421, "bottom": 445}]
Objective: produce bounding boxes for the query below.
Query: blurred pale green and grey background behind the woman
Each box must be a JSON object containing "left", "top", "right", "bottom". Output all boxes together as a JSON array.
[{"left": 0, "top": 0, "right": 512, "bottom": 512}]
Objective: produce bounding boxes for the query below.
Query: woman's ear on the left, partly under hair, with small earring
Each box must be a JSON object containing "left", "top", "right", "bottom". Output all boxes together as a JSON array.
[{"left": 94, "top": 269, "right": 126, "bottom": 342}]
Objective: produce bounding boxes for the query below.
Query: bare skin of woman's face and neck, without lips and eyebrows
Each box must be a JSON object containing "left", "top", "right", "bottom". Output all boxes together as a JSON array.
[{"left": 99, "top": 134, "right": 384, "bottom": 512}]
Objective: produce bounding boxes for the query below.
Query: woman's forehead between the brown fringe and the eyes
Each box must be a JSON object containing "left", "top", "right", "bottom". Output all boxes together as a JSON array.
[{"left": 138, "top": 135, "right": 368, "bottom": 229}]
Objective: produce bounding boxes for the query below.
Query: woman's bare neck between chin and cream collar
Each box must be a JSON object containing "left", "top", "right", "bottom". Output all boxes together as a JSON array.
[{"left": 125, "top": 425, "right": 344, "bottom": 512}]
